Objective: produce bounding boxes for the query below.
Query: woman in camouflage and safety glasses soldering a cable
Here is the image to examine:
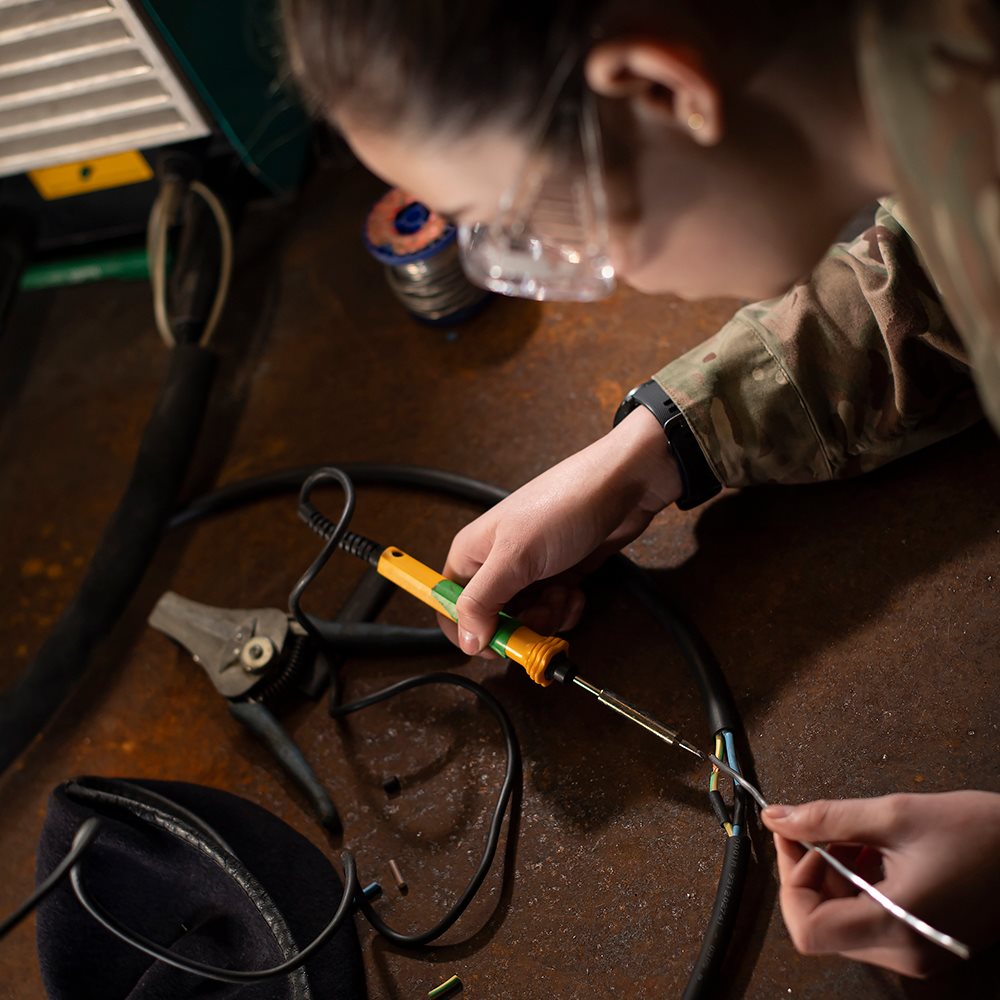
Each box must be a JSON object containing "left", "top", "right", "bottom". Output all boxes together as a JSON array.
[{"left": 286, "top": 0, "right": 1000, "bottom": 975}]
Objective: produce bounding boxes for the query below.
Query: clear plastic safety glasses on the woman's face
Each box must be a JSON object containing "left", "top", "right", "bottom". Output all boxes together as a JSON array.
[{"left": 459, "top": 85, "right": 615, "bottom": 302}]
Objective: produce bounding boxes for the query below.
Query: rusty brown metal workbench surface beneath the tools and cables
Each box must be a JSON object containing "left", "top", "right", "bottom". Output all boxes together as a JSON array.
[{"left": 0, "top": 171, "right": 1000, "bottom": 1000}]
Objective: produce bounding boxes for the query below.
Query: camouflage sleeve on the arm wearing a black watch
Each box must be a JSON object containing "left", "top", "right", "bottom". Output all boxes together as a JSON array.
[{"left": 654, "top": 203, "right": 981, "bottom": 486}]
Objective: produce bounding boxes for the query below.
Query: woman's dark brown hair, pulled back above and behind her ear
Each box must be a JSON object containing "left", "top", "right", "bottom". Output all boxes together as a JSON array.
[{"left": 282, "top": 0, "right": 816, "bottom": 134}]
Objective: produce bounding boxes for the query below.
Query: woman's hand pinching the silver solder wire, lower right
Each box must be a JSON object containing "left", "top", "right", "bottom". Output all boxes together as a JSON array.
[{"left": 761, "top": 791, "right": 1000, "bottom": 976}]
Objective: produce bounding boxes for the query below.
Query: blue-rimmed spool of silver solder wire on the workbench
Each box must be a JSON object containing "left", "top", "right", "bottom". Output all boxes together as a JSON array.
[{"left": 363, "top": 188, "right": 491, "bottom": 325}]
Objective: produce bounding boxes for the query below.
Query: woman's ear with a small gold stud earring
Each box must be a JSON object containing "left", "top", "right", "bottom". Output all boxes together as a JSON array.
[{"left": 584, "top": 38, "right": 723, "bottom": 146}]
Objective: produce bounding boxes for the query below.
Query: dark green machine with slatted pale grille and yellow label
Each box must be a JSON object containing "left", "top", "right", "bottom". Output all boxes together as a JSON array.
[{"left": 0, "top": 0, "right": 311, "bottom": 288}]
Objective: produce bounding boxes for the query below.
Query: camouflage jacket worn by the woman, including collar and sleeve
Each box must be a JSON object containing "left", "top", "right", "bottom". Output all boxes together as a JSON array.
[{"left": 655, "top": 0, "right": 1000, "bottom": 486}]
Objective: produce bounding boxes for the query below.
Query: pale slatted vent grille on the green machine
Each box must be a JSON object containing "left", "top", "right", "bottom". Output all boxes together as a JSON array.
[{"left": 0, "top": 0, "right": 209, "bottom": 177}]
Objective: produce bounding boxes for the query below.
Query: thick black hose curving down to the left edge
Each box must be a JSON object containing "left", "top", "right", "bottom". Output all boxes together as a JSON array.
[{"left": 0, "top": 344, "right": 215, "bottom": 773}]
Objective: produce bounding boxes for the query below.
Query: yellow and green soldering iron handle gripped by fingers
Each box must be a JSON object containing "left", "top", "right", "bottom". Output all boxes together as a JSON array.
[{"left": 377, "top": 545, "right": 569, "bottom": 687}]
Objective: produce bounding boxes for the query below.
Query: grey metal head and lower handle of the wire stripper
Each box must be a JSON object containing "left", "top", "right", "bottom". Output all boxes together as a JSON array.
[{"left": 149, "top": 591, "right": 342, "bottom": 833}]
